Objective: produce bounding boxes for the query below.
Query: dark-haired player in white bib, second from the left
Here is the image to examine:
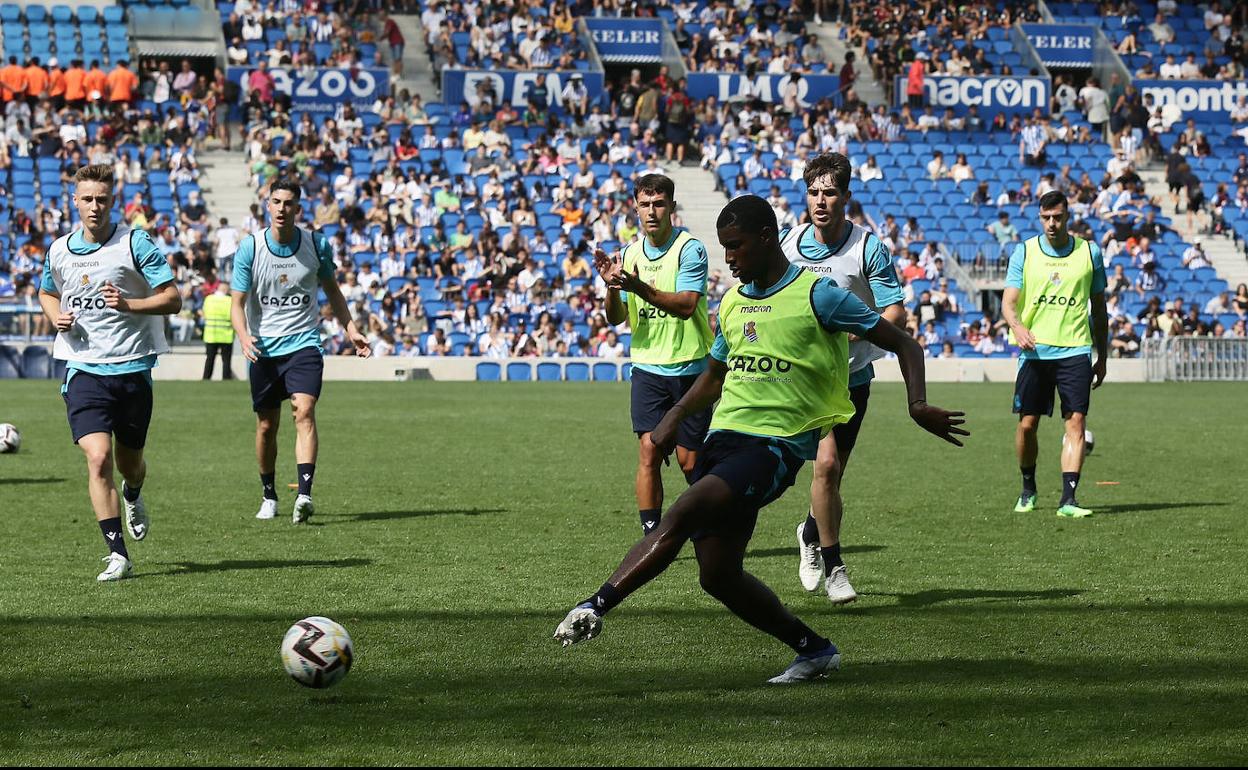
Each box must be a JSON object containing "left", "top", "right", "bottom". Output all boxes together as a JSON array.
[{"left": 230, "top": 178, "right": 371, "bottom": 524}]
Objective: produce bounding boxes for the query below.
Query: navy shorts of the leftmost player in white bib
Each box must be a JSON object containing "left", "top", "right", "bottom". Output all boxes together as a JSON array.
[{"left": 61, "top": 369, "right": 152, "bottom": 449}]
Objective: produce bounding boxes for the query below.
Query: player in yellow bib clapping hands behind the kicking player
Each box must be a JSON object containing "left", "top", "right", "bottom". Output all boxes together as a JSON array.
[{"left": 594, "top": 173, "right": 711, "bottom": 534}]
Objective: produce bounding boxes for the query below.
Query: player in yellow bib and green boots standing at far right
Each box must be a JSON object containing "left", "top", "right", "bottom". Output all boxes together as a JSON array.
[{"left": 1001, "top": 191, "right": 1109, "bottom": 519}]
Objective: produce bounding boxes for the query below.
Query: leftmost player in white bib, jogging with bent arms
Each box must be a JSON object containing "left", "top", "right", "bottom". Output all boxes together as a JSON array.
[{"left": 39, "top": 165, "right": 182, "bottom": 582}]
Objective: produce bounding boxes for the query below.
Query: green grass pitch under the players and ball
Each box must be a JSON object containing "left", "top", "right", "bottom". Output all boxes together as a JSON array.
[{"left": 0, "top": 372, "right": 1248, "bottom": 766}]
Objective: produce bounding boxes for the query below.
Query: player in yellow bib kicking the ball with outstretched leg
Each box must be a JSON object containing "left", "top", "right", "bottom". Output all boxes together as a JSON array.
[{"left": 554, "top": 196, "right": 967, "bottom": 684}]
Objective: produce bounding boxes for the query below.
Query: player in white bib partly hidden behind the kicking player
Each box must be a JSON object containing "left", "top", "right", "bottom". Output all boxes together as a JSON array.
[{"left": 780, "top": 152, "right": 906, "bottom": 604}]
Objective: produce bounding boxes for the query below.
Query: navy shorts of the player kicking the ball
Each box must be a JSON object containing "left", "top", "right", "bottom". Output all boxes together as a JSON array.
[{"left": 690, "top": 431, "right": 805, "bottom": 540}]
